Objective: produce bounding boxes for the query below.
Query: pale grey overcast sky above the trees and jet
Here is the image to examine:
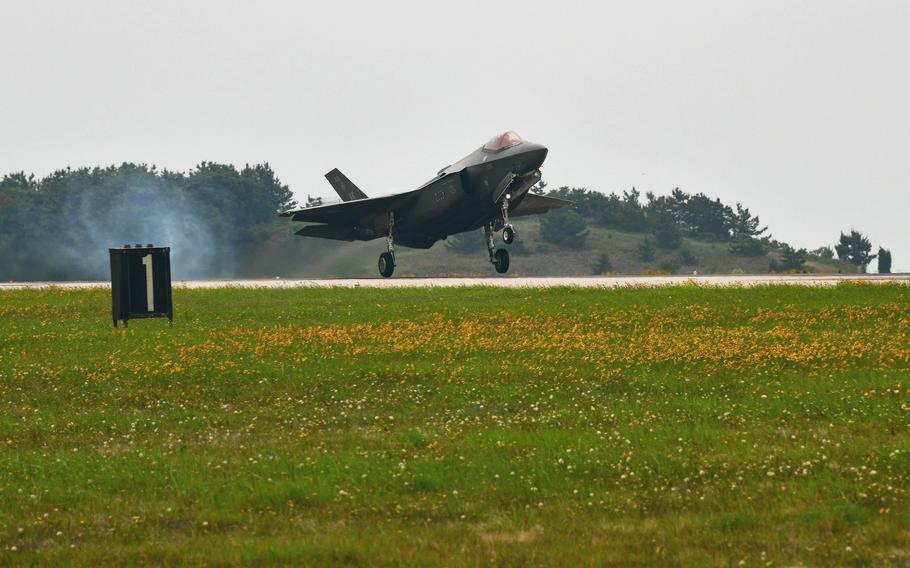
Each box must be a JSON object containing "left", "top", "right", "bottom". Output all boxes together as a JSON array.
[{"left": 0, "top": 0, "right": 910, "bottom": 270}]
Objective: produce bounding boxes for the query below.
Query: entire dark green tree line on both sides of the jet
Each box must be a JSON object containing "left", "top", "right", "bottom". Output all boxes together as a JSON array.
[{"left": 0, "top": 162, "right": 891, "bottom": 280}]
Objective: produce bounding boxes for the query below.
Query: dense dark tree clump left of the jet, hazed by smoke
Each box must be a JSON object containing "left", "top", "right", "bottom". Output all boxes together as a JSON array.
[{"left": 0, "top": 162, "right": 295, "bottom": 280}]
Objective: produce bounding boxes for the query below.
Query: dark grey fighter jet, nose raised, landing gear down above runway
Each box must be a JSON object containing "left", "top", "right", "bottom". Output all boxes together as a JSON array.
[{"left": 282, "top": 131, "right": 572, "bottom": 277}]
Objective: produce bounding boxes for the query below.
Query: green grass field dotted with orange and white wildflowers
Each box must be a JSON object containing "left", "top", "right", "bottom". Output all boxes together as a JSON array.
[{"left": 0, "top": 284, "right": 910, "bottom": 566}]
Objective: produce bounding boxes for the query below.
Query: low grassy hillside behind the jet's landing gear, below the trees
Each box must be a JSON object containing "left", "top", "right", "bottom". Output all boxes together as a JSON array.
[{"left": 239, "top": 218, "right": 855, "bottom": 278}]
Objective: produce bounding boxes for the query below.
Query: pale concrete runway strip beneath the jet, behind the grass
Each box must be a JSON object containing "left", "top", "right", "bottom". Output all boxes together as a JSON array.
[{"left": 0, "top": 274, "right": 910, "bottom": 291}]
